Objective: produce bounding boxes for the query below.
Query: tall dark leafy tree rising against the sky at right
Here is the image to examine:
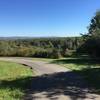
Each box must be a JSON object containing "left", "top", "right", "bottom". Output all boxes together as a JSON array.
[{"left": 78, "top": 11, "right": 100, "bottom": 57}]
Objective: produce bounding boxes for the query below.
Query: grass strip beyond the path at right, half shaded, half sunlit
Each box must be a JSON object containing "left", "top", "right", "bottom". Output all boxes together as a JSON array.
[{"left": 51, "top": 58, "right": 100, "bottom": 70}]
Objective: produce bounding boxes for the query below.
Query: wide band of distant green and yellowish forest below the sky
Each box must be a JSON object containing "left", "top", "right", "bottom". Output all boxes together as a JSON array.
[{"left": 0, "top": 37, "right": 83, "bottom": 58}]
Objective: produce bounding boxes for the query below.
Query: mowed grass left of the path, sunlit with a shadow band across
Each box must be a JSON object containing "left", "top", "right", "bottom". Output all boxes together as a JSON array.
[{"left": 0, "top": 61, "right": 33, "bottom": 100}]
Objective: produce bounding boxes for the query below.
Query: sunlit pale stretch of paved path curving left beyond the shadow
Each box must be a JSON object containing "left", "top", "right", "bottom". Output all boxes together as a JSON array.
[{"left": 0, "top": 57, "right": 68, "bottom": 75}]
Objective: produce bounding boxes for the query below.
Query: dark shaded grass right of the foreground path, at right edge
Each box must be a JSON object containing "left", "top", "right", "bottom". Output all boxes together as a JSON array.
[{"left": 76, "top": 68, "right": 100, "bottom": 94}]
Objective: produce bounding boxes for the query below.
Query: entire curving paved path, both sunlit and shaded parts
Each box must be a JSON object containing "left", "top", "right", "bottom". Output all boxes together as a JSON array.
[{"left": 0, "top": 57, "right": 100, "bottom": 100}]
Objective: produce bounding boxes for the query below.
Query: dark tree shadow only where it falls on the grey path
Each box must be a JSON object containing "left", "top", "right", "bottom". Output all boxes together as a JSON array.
[{"left": 27, "top": 72, "right": 90, "bottom": 100}]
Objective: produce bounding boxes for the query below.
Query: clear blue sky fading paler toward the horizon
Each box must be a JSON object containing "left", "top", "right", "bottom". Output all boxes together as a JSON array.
[{"left": 0, "top": 0, "right": 100, "bottom": 37}]
